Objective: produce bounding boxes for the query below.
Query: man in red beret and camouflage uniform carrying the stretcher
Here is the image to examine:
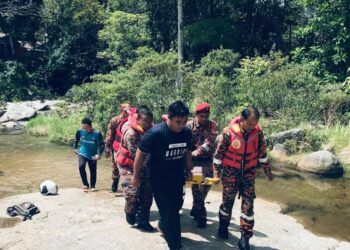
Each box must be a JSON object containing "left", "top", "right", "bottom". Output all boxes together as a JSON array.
[{"left": 187, "top": 102, "right": 219, "bottom": 228}]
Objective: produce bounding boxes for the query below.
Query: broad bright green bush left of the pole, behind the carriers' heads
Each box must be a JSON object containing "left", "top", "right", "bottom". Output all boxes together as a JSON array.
[{"left": 73, "top": 50, "right": 192, "bottom": 129}]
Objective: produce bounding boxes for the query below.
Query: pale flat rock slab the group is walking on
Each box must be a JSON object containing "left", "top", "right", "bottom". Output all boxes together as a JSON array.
[{"left": 0, "top": 189, "right": 350, "bottom": 250}]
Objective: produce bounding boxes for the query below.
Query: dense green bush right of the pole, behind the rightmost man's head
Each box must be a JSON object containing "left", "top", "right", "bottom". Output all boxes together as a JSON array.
[{"left": 236, "top": 53, "right": 320, "bottom": 124}]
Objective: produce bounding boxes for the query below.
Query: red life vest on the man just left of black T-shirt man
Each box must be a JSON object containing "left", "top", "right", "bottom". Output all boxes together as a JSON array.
[{"left": 116, "top": 114, "right": 145, "bottom": 167}]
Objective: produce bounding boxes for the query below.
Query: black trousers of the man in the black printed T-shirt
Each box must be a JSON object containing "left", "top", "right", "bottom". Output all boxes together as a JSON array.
[{"left": 151, "top": 177, "right": 183, "bottom": 249}]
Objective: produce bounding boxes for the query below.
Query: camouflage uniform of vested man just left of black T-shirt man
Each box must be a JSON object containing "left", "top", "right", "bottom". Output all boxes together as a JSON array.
[{"left": 118, "top": 128, "right": 153, "bottom": 224}]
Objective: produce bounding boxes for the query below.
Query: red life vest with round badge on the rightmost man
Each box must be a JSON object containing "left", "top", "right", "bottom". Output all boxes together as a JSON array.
[{"left": 222, "top": 117, "right": 261, "bottom": 169}]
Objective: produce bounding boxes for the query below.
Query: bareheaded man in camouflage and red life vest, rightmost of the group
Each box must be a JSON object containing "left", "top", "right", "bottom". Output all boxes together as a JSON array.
[{"left": 213, "top": 107, "right": 273, "bottom": 250}]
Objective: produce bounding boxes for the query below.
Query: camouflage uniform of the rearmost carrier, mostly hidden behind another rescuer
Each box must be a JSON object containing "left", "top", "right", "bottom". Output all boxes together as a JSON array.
[{"left": 105, "top": 116, "right": 123, "bottom": 182}]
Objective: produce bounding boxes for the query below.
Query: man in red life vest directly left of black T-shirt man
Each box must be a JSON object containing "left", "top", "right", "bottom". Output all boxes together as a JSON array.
[{"left": 116, "top": 106, "right": 154, "bottom": 232}]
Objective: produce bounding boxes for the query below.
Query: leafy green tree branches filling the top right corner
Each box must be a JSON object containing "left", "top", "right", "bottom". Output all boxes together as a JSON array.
[{"left": 294, "top": 0, "right": 350, "bottom": 80}]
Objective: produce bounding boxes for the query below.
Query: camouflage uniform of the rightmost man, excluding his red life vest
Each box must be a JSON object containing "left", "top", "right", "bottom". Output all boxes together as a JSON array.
[{"left": 213, "top": 124, "right": 270, "bottom": 239}]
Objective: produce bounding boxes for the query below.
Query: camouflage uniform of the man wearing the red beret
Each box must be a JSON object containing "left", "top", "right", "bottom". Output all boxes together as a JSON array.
[{"left": 187, "top": 118, "right": 218, "bottom": 220}]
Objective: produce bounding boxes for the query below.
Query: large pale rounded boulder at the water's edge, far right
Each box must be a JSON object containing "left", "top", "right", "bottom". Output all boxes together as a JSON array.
[{"left": 298, "top": 150, "right": 344, "bottom": 176}]
